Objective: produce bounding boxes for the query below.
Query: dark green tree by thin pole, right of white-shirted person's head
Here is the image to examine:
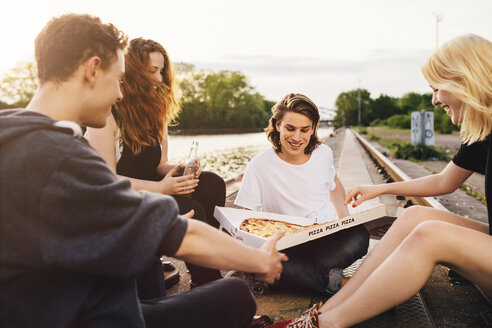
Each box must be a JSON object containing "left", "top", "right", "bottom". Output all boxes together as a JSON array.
[{"left": 333, "top": 89, "right": 372, "bottom": 127}]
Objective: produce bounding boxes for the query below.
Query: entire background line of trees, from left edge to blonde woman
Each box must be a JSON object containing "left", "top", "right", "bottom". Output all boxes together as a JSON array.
[{"left": 0, "top": 62, "right": 456, "bottom": 133}]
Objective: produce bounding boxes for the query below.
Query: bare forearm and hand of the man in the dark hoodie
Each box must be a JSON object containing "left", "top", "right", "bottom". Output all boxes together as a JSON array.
[{"left": 175, "top": 219, "right": 287, "bottom": 283}]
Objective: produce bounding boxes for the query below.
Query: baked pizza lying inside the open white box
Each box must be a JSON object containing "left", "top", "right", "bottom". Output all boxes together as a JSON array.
[{"left": 239, "top": 218, "right": 316, "bottom": 238}]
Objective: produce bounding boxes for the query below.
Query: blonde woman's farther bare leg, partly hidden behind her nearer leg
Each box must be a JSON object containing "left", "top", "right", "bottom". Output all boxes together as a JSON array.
[{"left": 320, "top": 206, "right": 488, "bottom": 312}]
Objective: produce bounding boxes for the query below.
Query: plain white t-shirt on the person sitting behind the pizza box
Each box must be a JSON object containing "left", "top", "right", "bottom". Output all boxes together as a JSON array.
[{"left": 234, "top": 144, "right": 337, "bottom": 223}]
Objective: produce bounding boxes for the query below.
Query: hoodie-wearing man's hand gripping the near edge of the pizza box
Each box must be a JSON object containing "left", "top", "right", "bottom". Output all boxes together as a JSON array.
[{"left": 258, "top": 230, "right": 289, "bottom": 284}]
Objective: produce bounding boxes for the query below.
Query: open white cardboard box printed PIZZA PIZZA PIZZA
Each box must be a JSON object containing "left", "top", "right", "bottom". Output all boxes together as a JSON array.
[{"left": 214, "top": 204, "right": 386, "bottom": 250}]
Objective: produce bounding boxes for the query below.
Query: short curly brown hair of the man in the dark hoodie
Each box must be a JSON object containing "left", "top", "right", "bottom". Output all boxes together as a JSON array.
[{"left": 35, "top": 14, "right": 128, "bottom": 84}]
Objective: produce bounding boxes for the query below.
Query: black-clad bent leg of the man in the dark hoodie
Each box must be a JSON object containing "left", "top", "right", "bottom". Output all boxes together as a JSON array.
[{"left": 140, "top": 278, "right": 256, "bottom": 328}]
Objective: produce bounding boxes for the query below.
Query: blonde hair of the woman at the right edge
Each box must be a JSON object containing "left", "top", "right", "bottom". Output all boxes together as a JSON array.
[{"left": 422, "top": 34, "right": 492, "bottom": 144}]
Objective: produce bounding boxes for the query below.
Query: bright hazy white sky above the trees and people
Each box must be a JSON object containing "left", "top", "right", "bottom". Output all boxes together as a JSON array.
[{"left": 0, "top": 0, "right": 492, "bottom": 108}]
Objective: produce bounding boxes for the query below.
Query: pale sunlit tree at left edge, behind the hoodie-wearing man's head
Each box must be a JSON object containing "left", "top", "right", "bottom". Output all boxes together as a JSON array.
[{"left": 0, "top": 61, "right": 38, "bottom": 107}]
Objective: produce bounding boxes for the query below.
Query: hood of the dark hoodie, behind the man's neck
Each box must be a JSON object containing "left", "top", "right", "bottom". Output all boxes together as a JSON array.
[{"left": 0, "top": 109, "right": 82, "bottom": 146}]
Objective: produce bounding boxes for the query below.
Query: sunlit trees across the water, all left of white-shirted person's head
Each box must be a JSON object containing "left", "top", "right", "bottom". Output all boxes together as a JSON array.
[{"left": 0, "top": 62, "right": 275, "bottom": 131}]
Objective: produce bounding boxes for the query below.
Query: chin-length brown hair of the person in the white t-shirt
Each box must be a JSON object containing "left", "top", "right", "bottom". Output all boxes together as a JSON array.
[{"left": 265, "top": 93, "right": 321, "bottom": 154}]
